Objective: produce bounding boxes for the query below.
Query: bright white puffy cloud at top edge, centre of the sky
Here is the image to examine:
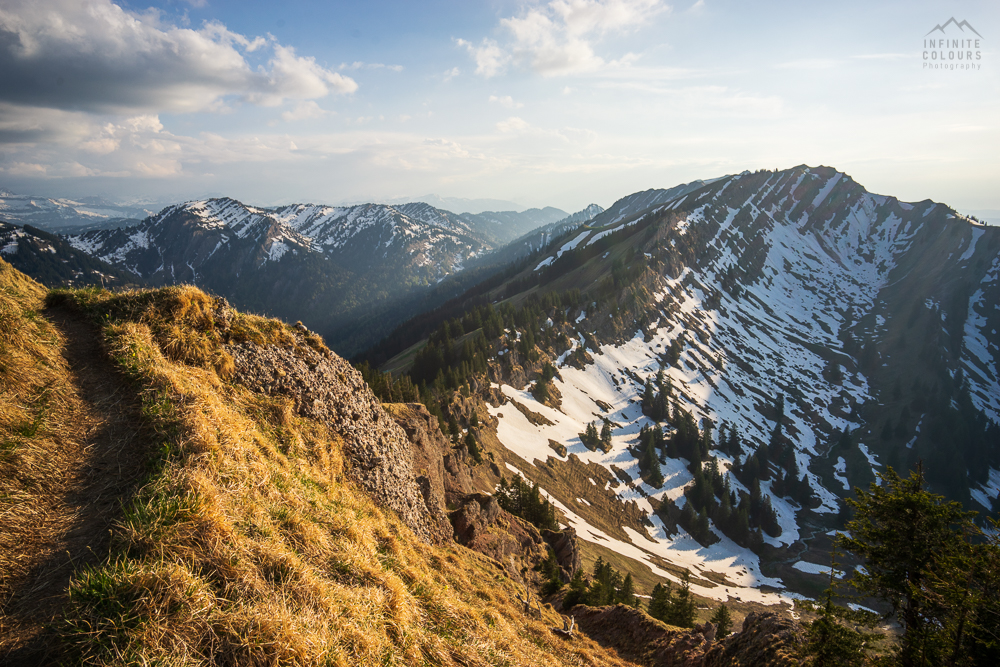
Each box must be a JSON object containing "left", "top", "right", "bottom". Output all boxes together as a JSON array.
[{"left": 458, "top": 0, "right": 670, "bottom": 78}]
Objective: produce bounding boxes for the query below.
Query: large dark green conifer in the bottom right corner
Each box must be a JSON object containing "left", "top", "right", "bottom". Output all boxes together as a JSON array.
[{"left": 836, "top": 465, "right": 1000, "bottom": 667}]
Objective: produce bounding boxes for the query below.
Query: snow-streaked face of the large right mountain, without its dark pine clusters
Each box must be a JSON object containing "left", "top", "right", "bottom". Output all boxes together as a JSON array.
[{"left": 470, "top": 167, "right": 1000, "bottom": 601}]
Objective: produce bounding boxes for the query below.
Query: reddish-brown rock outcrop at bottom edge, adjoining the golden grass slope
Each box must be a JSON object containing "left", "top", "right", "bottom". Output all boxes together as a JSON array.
[{"left": 563, "top": 604, "right": 716, "bottom": 667}]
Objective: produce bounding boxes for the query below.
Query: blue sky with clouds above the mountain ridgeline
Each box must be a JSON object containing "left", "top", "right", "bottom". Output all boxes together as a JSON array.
[{"left": 0, "top": 0, "right": 1000, "bottom": 213}]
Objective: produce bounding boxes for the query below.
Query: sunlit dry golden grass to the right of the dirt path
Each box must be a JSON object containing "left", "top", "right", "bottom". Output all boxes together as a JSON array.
[{"left": 37, "top": 287, "right": 640, "bottom": 665}]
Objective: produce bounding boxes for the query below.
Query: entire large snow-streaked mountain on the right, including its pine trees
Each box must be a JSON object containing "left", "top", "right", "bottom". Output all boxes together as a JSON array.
[{"left": 374, "top": 166, "right": 1000, "bottom": 601}]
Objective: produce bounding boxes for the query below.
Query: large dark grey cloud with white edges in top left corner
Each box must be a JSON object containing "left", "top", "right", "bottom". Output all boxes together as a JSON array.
[{"left": 0, "top": 0, "right": 358, "bottom": 114}]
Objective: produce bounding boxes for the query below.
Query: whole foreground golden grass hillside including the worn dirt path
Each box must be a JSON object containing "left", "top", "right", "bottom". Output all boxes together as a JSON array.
[{"left": 0, "top": 261, "right": 630, "bottom": 666}]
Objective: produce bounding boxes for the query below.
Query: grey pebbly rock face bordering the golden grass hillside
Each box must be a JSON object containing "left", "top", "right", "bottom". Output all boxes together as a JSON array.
[{"left": 227, "top": 332, "right": 451, "bottom": 542}]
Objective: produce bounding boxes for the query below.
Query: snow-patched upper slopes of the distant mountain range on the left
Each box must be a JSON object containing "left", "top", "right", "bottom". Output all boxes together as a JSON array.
[{"left": 72, "top": 198, "right": 562, "bottom": 284}]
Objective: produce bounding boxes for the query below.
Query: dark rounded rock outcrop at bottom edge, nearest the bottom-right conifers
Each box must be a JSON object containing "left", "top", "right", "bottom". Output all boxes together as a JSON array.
[{"left": 703, "top": 612, "right": 805, "bottom": 667}]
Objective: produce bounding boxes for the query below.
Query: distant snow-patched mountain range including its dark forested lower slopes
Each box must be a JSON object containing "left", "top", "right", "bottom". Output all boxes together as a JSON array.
[{"left": 64, "top": 199, "right": 580, "bottom": 354}]
